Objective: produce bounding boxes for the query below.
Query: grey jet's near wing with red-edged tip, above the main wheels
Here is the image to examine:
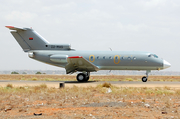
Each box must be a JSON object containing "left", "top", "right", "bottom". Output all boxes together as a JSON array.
[{"left": 65, "top": 56, "right": 99, "bottom": 74}]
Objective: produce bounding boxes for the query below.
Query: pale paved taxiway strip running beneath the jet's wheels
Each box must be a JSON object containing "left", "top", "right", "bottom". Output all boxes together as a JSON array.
[{"left": 0, "top": 80, "right": 180, "bottom": 88}]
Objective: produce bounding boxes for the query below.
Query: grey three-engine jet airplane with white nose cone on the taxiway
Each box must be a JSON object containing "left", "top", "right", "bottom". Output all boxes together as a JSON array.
[{"left": 5, "top": 26, "right": 171, "bottom": 82}]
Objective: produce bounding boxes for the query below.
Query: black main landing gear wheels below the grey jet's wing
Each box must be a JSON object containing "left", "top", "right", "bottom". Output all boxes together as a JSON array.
[{"left": 76, "top": 72, "right": 90, "bottom": 82}]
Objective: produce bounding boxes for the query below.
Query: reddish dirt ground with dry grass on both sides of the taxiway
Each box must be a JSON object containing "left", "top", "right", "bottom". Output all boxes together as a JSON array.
[{"left": 0, "top": 75, "right": 180, "bottom": 119}]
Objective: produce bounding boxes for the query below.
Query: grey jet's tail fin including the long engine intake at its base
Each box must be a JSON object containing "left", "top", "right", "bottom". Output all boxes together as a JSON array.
[{"left": 6, "top": 26, "right": 71, "bottom": 52}]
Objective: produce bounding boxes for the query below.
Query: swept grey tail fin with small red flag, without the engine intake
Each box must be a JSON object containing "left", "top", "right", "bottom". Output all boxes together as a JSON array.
[{"left": 6, "top": 26, "right": 49, "bottom": 52}]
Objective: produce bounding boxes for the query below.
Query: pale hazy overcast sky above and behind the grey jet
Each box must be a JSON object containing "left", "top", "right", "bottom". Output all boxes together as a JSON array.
[{"left": 0, "top": 0, "right": 180, "bottom": 71}]
